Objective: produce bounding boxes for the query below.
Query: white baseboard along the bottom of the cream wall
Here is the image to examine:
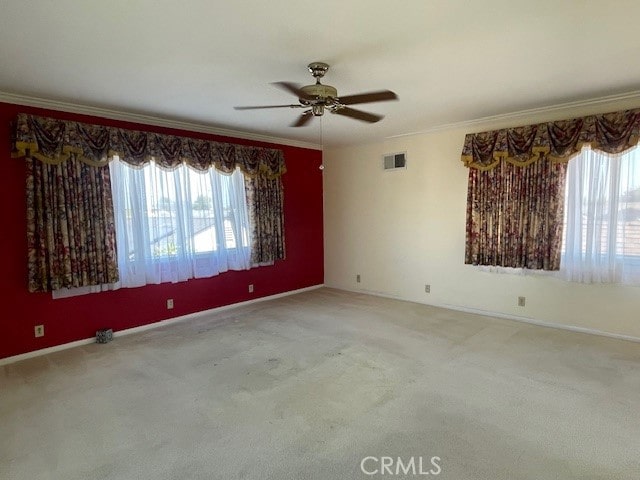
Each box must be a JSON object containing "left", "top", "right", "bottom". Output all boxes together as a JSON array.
[{"left": 326, "top": 285, "right": 640, "bottom": 343}]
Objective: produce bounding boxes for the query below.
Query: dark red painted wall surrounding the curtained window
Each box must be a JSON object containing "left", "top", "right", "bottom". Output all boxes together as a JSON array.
[{"left": 0, "top": 103, "right": 324, "bottom": 358}]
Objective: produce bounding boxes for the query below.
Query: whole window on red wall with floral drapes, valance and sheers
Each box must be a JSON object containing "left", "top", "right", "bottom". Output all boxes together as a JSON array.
[{"left": 11, "top": 113, "right": 286, "bottom": 298}]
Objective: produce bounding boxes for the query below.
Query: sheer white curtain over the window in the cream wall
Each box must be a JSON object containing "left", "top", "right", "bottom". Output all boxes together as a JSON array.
[{"left": 560, "top": 147, "right": 640, "bottom": 285}]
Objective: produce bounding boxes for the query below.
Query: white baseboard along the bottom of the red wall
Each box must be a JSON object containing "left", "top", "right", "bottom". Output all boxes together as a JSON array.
[{"left": 0, "top": 284, "right": 324, "bottom": 366}]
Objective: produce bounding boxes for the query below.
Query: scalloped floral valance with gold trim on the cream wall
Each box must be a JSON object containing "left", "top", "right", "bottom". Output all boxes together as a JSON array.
[{"left": 462, "top": 109, "right": 640, "bottom": 170}]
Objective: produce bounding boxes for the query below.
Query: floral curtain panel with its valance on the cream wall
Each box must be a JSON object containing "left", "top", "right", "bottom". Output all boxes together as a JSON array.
[{"left": 462, "top": 109, "right": 640, "bottom": 270}]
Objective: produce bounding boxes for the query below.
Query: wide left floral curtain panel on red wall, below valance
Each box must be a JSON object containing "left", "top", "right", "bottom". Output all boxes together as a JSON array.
[{"left": 27, "top": 158, "right": 118, "bottom": 292}]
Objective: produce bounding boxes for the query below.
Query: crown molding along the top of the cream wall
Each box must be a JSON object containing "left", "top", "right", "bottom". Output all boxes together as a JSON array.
[{"left": 386, "top": 90, "right": 640, "bottom": 139}]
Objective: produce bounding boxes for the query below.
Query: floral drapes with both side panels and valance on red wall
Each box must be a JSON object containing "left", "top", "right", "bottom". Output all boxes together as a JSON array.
[{"left": 12, "top": 114, "right": 286, "bottom": 292}]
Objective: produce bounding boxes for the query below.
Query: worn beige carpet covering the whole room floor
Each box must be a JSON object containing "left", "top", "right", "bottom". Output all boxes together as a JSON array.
[{"left": 0, "top": 289, "right": 640, "bottom": 480}]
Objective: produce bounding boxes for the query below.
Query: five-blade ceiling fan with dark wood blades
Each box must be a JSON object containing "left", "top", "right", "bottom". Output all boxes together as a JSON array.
[{"left": 234, "top": 62, "right": 398, "bottom": 127}]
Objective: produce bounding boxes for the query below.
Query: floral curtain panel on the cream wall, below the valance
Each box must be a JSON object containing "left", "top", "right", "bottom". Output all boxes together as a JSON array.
[{"left": 465, "top": 161, "right": 567, "bottom": 270}]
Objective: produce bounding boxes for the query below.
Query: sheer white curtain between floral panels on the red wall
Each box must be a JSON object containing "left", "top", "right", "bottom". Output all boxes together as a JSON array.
[{"left": 110, "top": 159, "right": 251, "bottom": 287}]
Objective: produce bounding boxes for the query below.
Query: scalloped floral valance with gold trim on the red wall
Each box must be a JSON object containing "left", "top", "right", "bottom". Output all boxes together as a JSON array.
[{"left": 12, "top": 114, "right": 286, "bottom": 178}]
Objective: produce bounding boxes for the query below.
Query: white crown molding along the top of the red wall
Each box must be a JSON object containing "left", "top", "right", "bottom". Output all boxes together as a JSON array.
[{"left": 0, "top": 91, "right": 322, "bottom": 150}]
